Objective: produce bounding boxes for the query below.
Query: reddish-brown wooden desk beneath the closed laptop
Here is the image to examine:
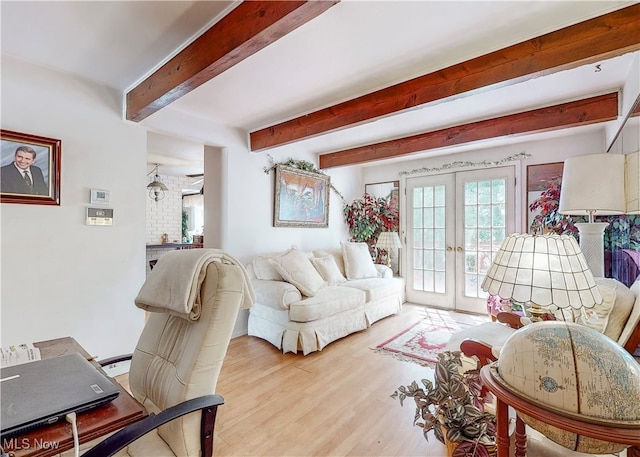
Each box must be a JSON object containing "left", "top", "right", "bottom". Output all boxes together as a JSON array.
[{"left": 2, "top": 338, "right": 147, "bottom": 457}]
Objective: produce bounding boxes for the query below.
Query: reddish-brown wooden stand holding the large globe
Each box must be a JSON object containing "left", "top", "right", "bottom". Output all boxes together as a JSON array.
[{"left": 480, "top": 365, "right": 640, "bottom": 457}]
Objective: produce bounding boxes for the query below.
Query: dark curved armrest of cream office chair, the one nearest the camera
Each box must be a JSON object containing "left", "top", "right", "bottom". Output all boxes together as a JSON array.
[{"left": 82, "top": 395, "right": 224, "bottom": 457}]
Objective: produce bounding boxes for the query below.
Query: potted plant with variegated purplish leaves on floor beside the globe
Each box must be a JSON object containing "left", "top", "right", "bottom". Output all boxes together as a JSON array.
[{"left": 391, "top": 351, "right": 496, "bottom": 457}]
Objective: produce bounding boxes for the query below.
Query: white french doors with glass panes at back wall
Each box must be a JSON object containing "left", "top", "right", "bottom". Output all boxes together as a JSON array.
[{"left": 405, "top": 166, "right": 515, "bottom": 313}]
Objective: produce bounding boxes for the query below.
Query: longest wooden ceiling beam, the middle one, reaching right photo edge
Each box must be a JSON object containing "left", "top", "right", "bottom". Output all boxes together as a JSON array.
[{"left": 250, "top": 4, "right": 640, "bottom": 151}]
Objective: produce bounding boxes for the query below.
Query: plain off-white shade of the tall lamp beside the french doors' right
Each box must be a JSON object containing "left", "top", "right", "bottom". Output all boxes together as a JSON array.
[{"left": 558, "top": 154, "right": 625, "bottom": 216}]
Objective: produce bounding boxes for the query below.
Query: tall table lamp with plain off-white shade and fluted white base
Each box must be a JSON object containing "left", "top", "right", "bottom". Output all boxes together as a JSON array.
[{"left": 558, "top": 153, "right": 625, "bottom": 277}]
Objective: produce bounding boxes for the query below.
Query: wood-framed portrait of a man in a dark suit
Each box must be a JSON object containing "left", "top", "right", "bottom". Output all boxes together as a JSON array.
[{"left": 0, "top": 130, "right": 62, "bottom": 205}]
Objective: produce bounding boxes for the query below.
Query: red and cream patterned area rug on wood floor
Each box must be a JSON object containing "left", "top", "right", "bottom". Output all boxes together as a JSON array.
[{"left": 373, "top": 319, "right": 470, "bottom": 367}]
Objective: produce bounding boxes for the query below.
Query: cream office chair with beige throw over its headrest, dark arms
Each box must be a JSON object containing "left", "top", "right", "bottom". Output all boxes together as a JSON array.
[{"left": 83, "top": 249, "right": 254, "bottom": 457}]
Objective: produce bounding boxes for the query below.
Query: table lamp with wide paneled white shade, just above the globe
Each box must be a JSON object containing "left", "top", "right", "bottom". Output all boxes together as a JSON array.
[{"left": 482, "top": 233, "right": 602, "bottom": 321}]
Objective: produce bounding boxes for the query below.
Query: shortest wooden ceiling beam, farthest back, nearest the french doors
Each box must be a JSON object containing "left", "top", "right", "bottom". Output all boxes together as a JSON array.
[{"left": 320, "top": 92, "right": 618, "bottom": 169}]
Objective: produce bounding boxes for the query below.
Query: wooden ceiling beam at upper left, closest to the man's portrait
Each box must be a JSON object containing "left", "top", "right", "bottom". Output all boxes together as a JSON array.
[{"left": 126, "top": 0, "right": 339, "bottom": 122}]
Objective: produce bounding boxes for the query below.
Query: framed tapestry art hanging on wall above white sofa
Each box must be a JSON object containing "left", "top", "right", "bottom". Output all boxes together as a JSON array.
[{"left": 273, "top": 165, "right": 331, "bottom": 227}]
